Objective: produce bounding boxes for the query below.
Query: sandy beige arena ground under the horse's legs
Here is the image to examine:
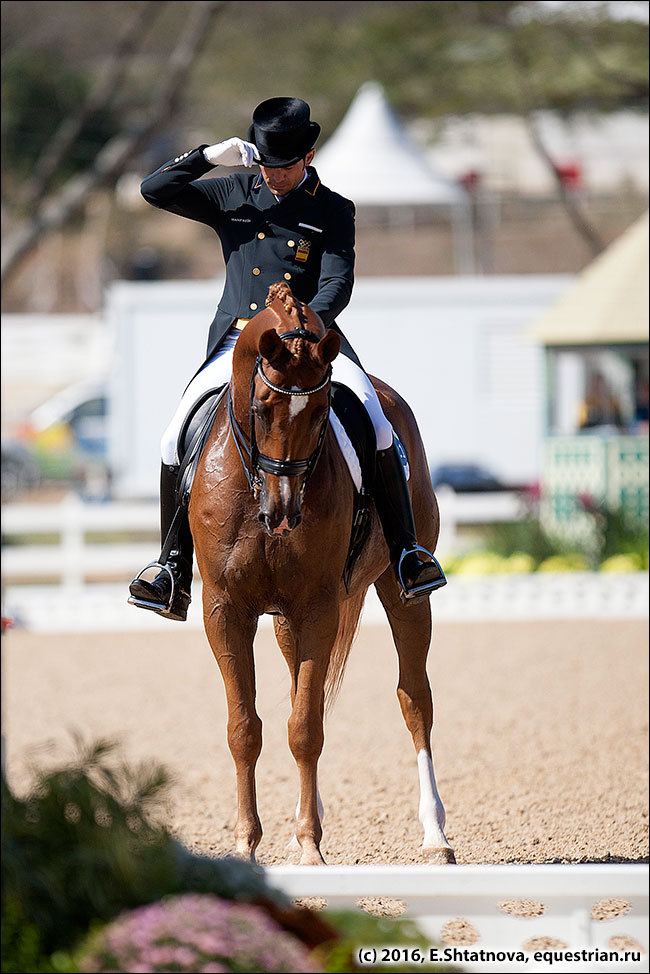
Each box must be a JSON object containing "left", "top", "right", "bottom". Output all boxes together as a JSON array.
[{"left": 3, "top": 620, "right": 648, "bottom": 864}]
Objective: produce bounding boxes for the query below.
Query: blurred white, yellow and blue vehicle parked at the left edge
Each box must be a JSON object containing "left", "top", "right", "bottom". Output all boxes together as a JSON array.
[{"left": 2, "top": 380, "right": 109, "bottom": 499}]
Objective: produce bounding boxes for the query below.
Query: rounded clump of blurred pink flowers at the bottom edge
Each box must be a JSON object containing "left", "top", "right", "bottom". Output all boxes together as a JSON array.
[{"left": 79, "top": 893, "right": 318, "bottom": 974}]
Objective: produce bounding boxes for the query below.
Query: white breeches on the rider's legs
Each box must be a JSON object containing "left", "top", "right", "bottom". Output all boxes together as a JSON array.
[{"left": 160, "top": 329, "right": 393, "bottom": 466}]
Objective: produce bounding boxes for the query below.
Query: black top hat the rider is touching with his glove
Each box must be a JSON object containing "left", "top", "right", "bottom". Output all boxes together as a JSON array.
[{"left": 248, "top": 98, "right": 320, "bottom": 169}]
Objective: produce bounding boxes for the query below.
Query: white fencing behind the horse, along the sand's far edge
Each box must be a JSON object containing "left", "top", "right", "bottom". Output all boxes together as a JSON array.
[{"left": 2, "top": 494, "right": 648, "bottom": 632}]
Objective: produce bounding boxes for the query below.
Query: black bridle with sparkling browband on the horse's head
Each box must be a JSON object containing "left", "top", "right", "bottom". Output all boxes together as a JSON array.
[{"left": 228, "top": 328, "right": 332, "bottom": 497}]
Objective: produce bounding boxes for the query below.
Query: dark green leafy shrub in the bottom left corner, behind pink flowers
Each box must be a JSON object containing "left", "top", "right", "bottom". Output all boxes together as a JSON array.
[{"left": 0, "top": 739, "right": 298, "bottom": 974}]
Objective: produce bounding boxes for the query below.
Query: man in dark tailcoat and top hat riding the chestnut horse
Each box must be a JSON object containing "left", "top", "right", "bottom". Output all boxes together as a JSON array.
[{"left": 129, "top": 98, "right": 446, "bottom": 620}]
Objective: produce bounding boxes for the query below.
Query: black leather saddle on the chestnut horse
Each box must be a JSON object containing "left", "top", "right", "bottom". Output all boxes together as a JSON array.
[{"left": 170, "top": 382, "right": 377, "bottom": 591}]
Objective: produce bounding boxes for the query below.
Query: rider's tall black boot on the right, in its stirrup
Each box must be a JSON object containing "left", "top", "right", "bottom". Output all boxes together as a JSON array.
[{"left": 375, "top": 440, "right": 447, "bottom": 602}]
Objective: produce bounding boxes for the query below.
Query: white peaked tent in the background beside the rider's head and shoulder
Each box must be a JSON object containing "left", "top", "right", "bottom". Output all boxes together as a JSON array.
[{"left": 314, "top": 81, "right": 473, "bottom": 273}]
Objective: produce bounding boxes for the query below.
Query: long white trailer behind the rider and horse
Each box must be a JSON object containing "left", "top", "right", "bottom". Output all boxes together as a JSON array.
[{"left": 106, "top": 275, "right": 574, "bottom": 498}]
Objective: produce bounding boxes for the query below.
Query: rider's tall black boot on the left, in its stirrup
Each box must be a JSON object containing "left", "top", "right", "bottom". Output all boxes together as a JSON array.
[{"left": 129, "top": 463, "right": 194, "bottom": 622}]
